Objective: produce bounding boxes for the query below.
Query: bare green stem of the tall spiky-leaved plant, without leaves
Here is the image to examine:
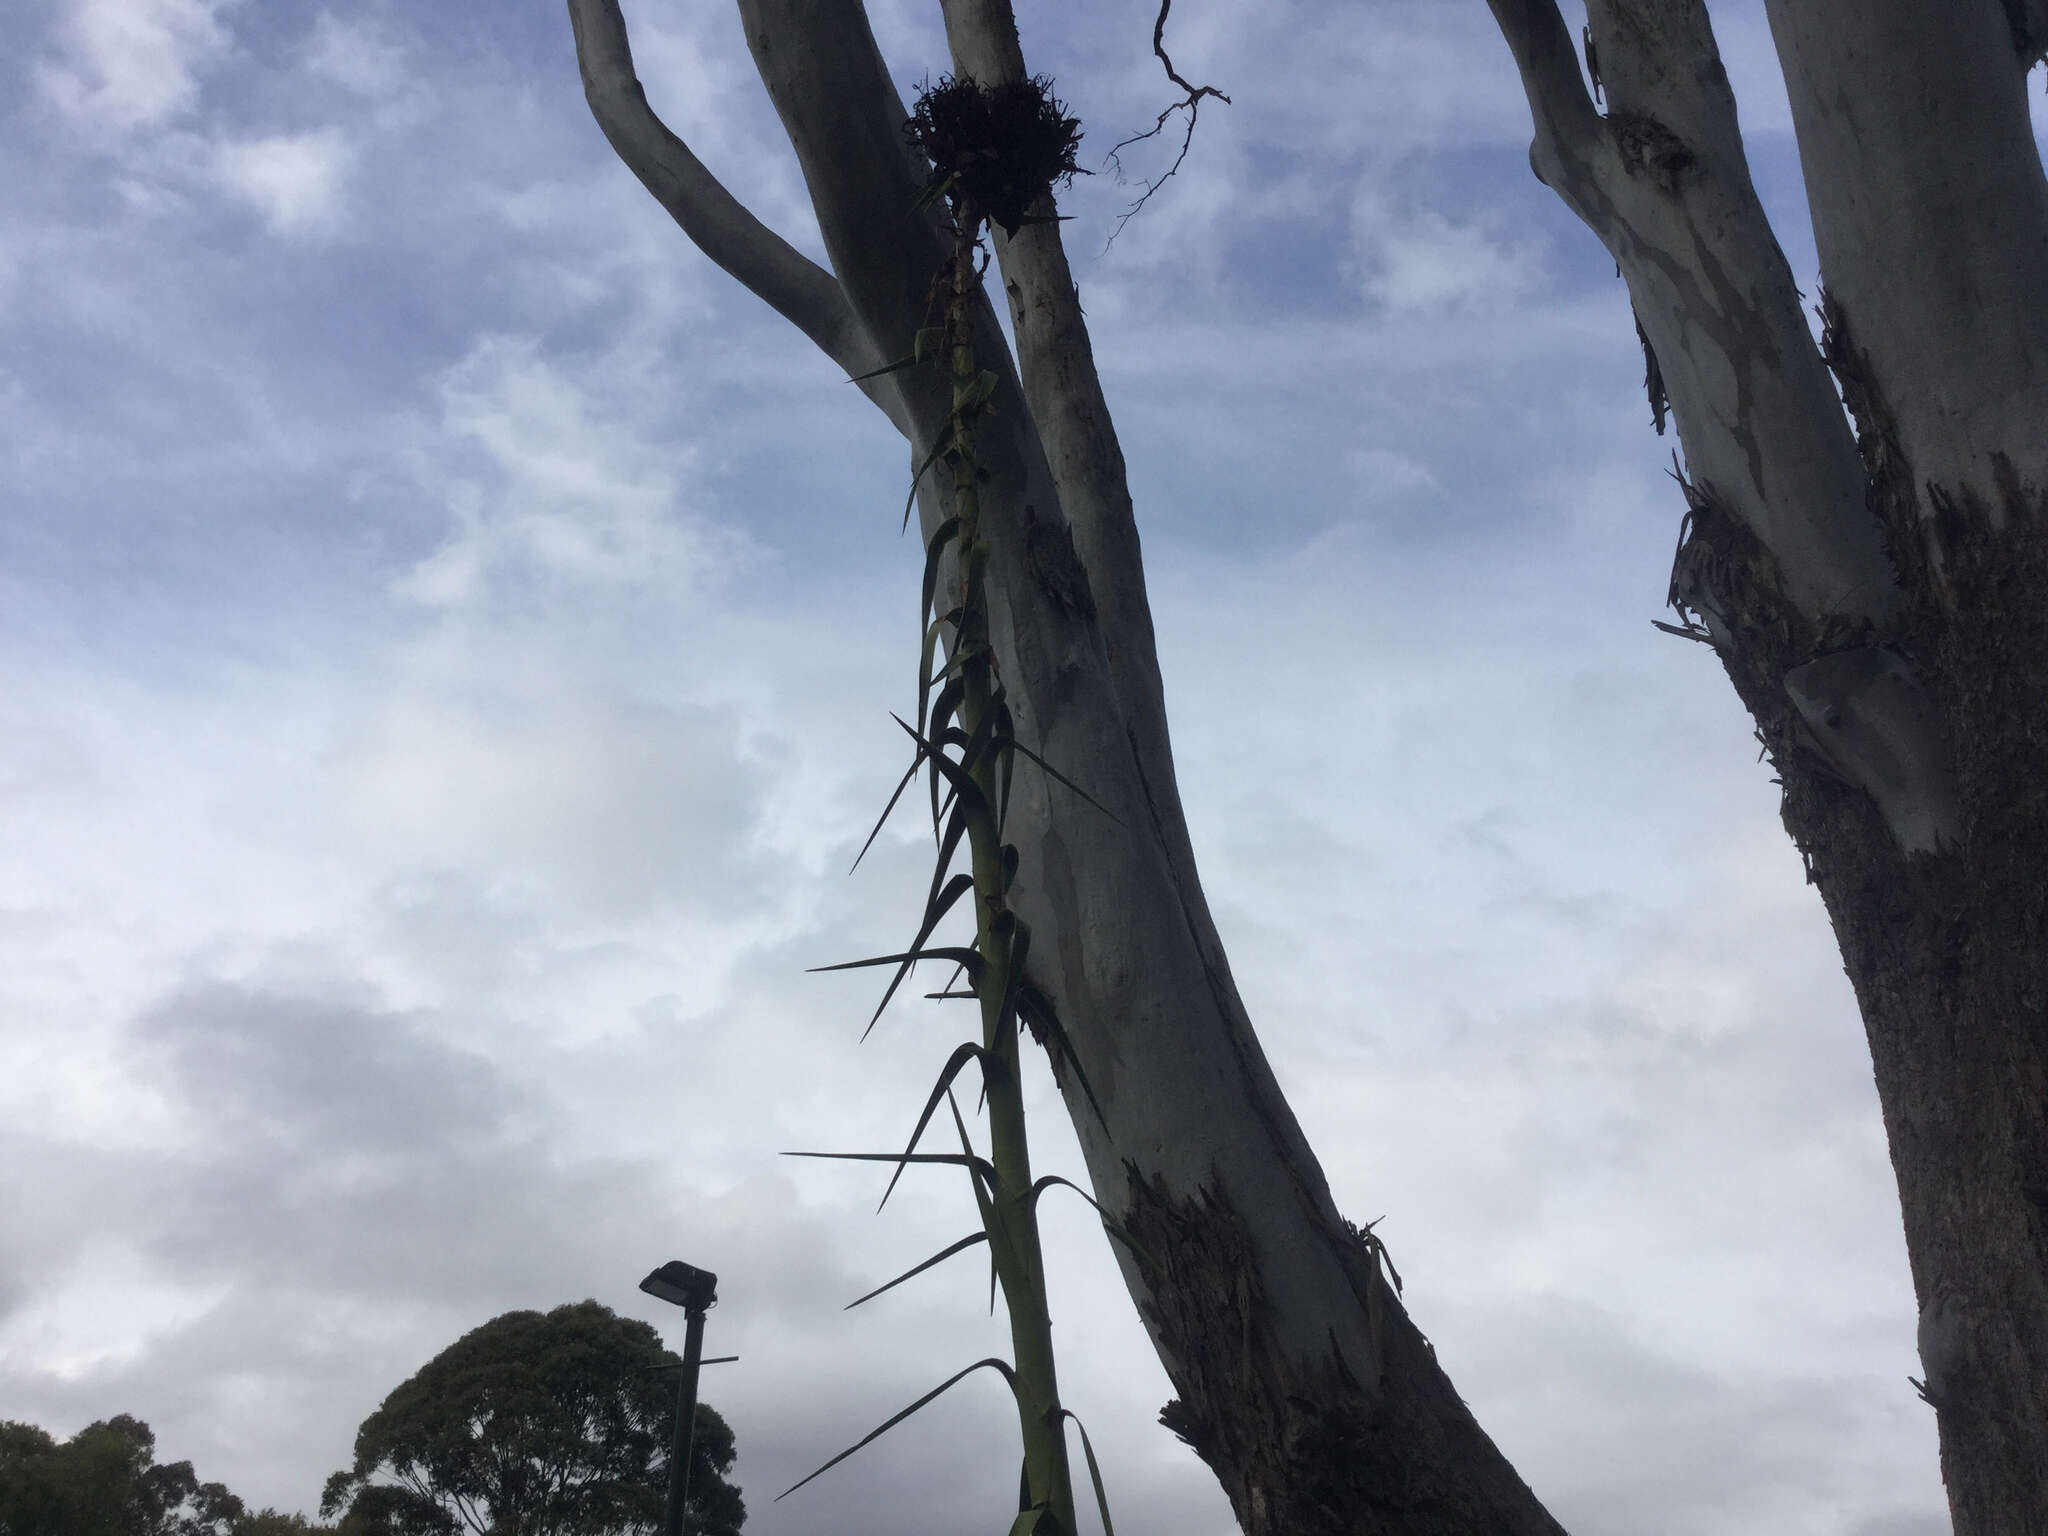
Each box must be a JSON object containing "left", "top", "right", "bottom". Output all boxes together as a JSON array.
[{"left": 946, "top": 207, "right": 1077, "bottom": 1536}]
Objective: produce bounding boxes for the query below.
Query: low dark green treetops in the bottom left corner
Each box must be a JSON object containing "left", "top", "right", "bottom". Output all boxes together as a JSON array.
[{"left": 0, "top": 1413, "right": 244, "bottom": 1536}]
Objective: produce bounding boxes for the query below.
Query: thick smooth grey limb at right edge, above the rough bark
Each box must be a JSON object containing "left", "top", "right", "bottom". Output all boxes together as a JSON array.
[{"left": 1767, "top": 0, "right": 2048, "bottom": 505}]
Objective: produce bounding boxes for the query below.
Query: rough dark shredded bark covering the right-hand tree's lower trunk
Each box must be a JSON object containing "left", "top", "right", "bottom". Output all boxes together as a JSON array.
[{"left": 1673, "top": 295, "right": 2048, "bottom": 1530}]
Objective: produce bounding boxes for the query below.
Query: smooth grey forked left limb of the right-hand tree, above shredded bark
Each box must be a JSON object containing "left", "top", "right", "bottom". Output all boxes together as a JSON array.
[{"left": 1489, "top": 0, "right": 1898, "bottom": 625}]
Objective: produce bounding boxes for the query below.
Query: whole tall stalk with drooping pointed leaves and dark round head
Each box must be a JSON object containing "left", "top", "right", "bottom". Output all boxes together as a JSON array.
[{"left": 791, "top": 80, "right": 1128, "bottom": 1536}]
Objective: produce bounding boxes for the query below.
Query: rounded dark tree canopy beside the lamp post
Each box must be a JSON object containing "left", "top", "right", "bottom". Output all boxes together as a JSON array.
[{"left": 315, "top": 1300, "right": 745, "bottom": 1536}]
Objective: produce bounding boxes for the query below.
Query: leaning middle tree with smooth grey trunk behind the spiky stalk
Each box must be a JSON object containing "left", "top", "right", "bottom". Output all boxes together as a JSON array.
[{"left": 569, "top": 0, "right": 1559, "bottom": 1536}]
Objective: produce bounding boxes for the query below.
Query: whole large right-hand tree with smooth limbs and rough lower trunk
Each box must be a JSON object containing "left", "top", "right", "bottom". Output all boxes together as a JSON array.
[{"left": 1491, "top": 0, "right": 2048, "bottom": 1536}]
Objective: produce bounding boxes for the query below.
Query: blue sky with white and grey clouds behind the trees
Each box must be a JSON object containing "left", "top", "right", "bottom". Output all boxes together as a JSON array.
[{"left": 0, "top": 0, "right": 1998, "bottom": 1536}]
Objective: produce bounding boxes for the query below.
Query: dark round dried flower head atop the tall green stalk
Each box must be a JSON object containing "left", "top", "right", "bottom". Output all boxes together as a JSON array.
[{"left": 903, "top": 76, "right": 1085, "bottom": 236}]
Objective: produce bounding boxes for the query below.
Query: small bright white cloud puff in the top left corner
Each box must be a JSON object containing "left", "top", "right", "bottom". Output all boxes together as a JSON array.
[{"left": 37, "top": 0, "right": 229, "bottom": 137}]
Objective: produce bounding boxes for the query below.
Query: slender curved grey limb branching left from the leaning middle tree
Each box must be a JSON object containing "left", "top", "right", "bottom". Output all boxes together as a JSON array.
[{"left": 569, "top": 0, "right": 909, "bottom": 436}]
